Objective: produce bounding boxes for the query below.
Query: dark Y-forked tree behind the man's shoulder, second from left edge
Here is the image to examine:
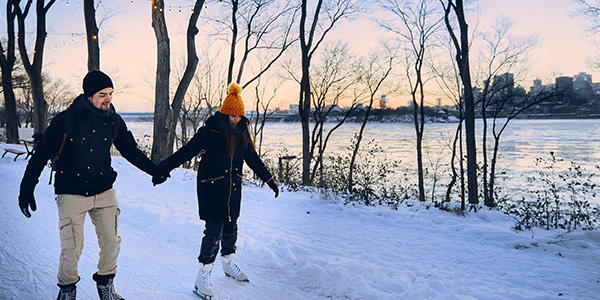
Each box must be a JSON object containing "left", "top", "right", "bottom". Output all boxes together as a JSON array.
[{"left": 13, "top": 0, "right": 56, "bottom": 132}]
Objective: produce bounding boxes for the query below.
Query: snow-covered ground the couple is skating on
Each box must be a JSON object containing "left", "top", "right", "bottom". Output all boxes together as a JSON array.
[{"left": 0, "top": 143, "right": 600, "bottom": 300}]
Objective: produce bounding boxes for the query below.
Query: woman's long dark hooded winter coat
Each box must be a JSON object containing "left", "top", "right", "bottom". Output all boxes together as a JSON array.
[{"left": 160, "top": 112, "right": 273, "bottom": 221}]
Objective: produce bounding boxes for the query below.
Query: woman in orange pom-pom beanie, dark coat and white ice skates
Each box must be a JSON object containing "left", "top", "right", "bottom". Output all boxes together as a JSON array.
[{"left": 152, "top": 84, "right": 279, "bottom": 298}]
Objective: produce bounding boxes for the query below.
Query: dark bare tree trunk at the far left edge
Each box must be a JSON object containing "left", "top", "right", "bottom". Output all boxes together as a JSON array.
[{"left": 0, "top": 0, "right": 19, "bottom": 144}]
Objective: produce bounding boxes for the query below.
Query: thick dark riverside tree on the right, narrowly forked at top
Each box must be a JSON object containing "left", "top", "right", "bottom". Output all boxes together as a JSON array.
[{"left": 440, "top": 0, "right": 479, "bottom": 204}]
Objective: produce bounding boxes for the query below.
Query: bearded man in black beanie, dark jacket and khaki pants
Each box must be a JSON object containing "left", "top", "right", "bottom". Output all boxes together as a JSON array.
[{"left": 19, "top": 70, "right": 155, "bottom": 300}]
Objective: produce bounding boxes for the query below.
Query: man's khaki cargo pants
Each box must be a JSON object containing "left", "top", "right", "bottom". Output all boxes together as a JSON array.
[{"left": 56, "top": 189, "right": 121, "bottom": 285}]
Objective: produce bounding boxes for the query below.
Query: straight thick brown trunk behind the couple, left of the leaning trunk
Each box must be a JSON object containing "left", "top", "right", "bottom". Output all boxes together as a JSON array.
[{"left": 151, "top": 0, "right": 173, "bottom": 162}]
